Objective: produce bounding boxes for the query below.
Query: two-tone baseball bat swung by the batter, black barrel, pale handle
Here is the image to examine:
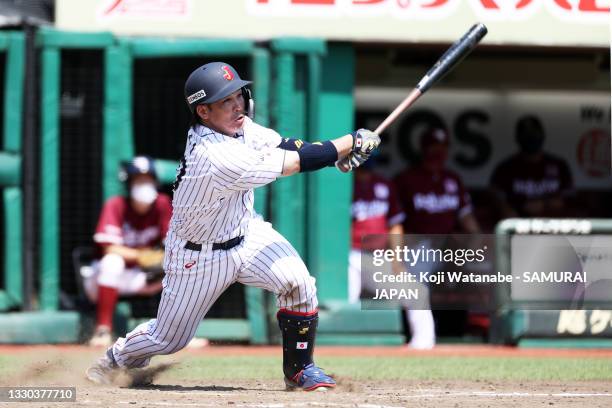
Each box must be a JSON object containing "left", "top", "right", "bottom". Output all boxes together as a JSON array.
[{"left": 374, "top": 23, "right": 487, "bottom": 135}]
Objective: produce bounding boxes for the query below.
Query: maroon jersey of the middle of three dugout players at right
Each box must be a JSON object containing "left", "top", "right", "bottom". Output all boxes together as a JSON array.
[{"left": 394, "top": 167, "right": 472, "bottom": 234}]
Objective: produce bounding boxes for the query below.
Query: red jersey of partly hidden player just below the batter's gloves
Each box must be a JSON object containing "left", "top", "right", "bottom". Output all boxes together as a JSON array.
[{"left": 351, "top": 173, "right": 406, "bottom": 249}]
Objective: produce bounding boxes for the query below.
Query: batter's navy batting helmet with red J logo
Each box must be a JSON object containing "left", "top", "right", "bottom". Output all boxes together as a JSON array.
[{"left": 185, "top": 62, "right": 251, "bottom": 113}]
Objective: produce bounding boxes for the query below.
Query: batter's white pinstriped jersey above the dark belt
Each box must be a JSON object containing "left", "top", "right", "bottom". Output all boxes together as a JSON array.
[{"left": 170, "top": 118, "right": 285, "bottom": 243}]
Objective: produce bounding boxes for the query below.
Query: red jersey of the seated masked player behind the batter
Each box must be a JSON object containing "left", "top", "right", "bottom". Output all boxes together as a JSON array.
[{"left": 94, "top": 193, "right": 172, "bottom": 248}]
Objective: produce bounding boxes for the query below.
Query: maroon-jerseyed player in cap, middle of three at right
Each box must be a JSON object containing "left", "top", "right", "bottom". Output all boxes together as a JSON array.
[{"left": 394, "top": 128, "right": 480, "bottom": 348}]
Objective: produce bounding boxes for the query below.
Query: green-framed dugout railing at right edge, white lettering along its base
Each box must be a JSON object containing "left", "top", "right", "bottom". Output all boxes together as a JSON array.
[{"left": 490, "top": 218, "right": 612, "bottom": 347}]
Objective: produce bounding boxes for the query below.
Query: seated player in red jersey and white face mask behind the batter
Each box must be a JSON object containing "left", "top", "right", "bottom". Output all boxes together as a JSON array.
[{"left": 84, "top": 156, "right": 172, "bottom": 346}]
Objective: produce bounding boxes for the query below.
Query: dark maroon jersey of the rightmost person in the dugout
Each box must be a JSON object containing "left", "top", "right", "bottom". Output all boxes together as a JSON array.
[{"left": 491, "top": 153, "right": 573, "bottom": 215}]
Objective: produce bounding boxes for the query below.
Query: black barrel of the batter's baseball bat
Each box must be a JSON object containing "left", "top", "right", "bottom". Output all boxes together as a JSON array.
[{"left": 416, "top": 23, "right": 488, "bottom": 93}]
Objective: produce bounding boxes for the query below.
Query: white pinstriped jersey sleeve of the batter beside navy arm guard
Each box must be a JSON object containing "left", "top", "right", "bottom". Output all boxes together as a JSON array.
[{"left": 209, "top": 143, "right": 285, "bottom": 191}]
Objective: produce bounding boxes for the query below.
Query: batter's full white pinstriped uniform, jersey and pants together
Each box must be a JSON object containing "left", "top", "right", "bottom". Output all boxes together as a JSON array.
[{"left": 113, "top": 118, "right": 317, "bottom": 368}]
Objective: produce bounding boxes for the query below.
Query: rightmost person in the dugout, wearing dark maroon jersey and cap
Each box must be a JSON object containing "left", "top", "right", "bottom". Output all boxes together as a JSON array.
[{"left": 491, "top": 115, "right": 573, "bottom": 218}]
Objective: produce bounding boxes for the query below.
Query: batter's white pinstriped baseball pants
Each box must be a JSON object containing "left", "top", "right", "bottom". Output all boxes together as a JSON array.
[{"left": 113, "top": 219, "right": 318, "bottom": 368}]
